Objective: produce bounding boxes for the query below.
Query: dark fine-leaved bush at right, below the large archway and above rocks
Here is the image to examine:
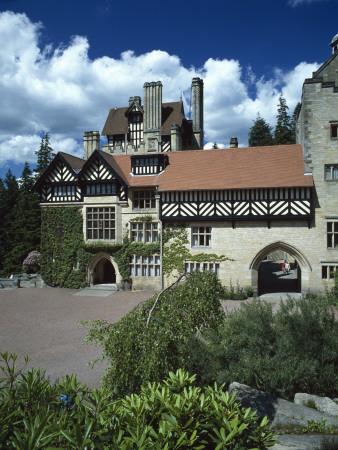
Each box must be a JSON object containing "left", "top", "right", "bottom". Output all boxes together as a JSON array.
[{"left": 193, "top": 295, "right": 338, "bottom": 399}]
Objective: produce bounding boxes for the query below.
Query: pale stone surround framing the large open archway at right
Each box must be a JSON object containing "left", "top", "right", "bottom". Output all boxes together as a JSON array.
[{"left": 250, "top": 241, "right": 312, "bottom": 294}]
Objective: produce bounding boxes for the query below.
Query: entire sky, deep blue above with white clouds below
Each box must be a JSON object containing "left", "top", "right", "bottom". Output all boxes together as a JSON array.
[{"left": 0, "top": 0, "right": 338, "bottom": 177}]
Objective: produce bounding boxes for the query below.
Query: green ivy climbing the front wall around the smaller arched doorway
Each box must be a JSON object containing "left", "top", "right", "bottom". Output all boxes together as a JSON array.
[{"left": 41, "top": 207, "right": 229, "bottom": 288}]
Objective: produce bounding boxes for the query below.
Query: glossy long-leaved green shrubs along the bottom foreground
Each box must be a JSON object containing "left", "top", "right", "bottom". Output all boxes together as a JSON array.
[{"left": 0, "top": 352, "right": 275, "bottom": 450}]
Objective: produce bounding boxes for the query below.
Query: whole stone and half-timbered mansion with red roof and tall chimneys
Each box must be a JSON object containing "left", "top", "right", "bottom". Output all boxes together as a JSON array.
[{"left": 36, "top": 37, "right": 338, "bottom": 292}]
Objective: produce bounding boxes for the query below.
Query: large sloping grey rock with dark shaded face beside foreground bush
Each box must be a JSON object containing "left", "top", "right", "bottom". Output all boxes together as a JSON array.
[{"left": 228, "top": 383, "right": 338, "bottom": 428}]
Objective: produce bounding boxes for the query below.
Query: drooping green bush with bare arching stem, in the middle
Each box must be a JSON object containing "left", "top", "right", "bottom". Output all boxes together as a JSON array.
[{"left": 81, "top": 272, "right": 224, "bottom": 395}]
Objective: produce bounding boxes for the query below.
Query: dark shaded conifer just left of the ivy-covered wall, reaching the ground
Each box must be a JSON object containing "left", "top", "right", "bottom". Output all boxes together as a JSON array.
[{"left": 4, "top": 162, "right": 41, "bottom": 274}]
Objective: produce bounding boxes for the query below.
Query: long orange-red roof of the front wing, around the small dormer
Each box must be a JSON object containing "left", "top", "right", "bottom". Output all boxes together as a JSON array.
[{"left": 101, "top": 144, "right": 313, "bottom": 192}]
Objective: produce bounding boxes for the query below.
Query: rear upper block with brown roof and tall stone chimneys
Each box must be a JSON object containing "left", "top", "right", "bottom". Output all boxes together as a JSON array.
[{"left": 84, "top": 78, "right": 203, "bottom": 159}]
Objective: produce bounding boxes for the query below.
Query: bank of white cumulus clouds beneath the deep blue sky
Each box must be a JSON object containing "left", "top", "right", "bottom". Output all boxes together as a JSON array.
[{"left": 0, "top": 12, "right": 318, "bottom": 166}]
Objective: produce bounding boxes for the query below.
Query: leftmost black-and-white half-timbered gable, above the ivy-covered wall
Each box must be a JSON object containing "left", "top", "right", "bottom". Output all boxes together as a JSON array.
[{"left": 36, "top": 152, "right": 85, "bottom": 203}]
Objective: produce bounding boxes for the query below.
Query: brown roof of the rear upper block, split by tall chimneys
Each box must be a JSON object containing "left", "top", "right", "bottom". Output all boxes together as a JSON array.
[{"left": 101, "top": 102, "right": 185, "bottom": 136}]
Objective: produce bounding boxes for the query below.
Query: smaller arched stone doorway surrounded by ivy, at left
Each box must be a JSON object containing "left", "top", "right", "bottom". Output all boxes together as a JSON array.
[{"left": 87, "top": 252, "right": 121, "bottom": 286}]
